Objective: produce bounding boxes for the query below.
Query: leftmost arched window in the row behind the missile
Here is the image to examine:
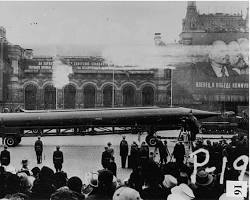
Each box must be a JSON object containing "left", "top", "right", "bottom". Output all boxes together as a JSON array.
[{"left": 24, "top": 84, "right": 37, "bottom": 110}]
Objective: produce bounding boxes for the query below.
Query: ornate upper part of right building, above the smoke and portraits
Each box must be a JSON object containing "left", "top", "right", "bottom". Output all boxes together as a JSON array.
[{"left": 180, "top": 1, "right": 249, "bottom": 45}]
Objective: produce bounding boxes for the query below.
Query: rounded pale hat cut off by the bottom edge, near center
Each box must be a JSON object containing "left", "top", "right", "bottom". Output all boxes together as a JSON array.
[{"left": 112, "top": 186, "right": 142, "bottom": 200}]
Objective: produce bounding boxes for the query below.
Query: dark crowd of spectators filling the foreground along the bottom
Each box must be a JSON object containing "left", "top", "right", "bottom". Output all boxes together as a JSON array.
[{"left": 0, "top": 133, "right": 248, "bottom": 200}]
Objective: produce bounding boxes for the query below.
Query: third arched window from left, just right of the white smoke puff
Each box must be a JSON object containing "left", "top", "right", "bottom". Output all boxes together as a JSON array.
[{"left": 63, "top": 85, "right": 76, "bottom": 109}]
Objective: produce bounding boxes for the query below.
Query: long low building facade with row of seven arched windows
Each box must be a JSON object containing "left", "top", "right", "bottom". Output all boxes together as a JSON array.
[{"left": 0, "top": 28, "right": 171, "bottom": 110}]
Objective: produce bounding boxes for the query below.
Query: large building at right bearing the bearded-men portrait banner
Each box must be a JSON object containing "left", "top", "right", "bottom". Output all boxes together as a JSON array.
[{"left": 176, "top": 1, "right": 249, "bottom": 113}]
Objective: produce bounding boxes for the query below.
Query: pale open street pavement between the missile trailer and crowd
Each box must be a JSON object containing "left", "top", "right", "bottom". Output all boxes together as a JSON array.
[{"left": 1, "top": 130, "right": 232, "bottom": 182}]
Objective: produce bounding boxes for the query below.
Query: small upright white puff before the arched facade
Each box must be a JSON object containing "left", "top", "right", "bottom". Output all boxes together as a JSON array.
[{"left": 52, "top": 56, "right": 73, "bottom": 89}]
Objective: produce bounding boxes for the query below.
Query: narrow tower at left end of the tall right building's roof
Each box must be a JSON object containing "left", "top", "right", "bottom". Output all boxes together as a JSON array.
[{"left": 182, "top": 1, "right": 199, "bottom": 31}]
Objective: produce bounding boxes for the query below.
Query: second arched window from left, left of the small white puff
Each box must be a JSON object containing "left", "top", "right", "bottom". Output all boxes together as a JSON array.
[{"left": 44, "top": 85, "right": 56, "bottom": 109}]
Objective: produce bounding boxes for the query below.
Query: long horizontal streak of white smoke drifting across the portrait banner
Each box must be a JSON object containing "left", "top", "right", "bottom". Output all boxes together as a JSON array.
[{"left": 102, "top": 38, "right": 249, "bottom": 69}]
